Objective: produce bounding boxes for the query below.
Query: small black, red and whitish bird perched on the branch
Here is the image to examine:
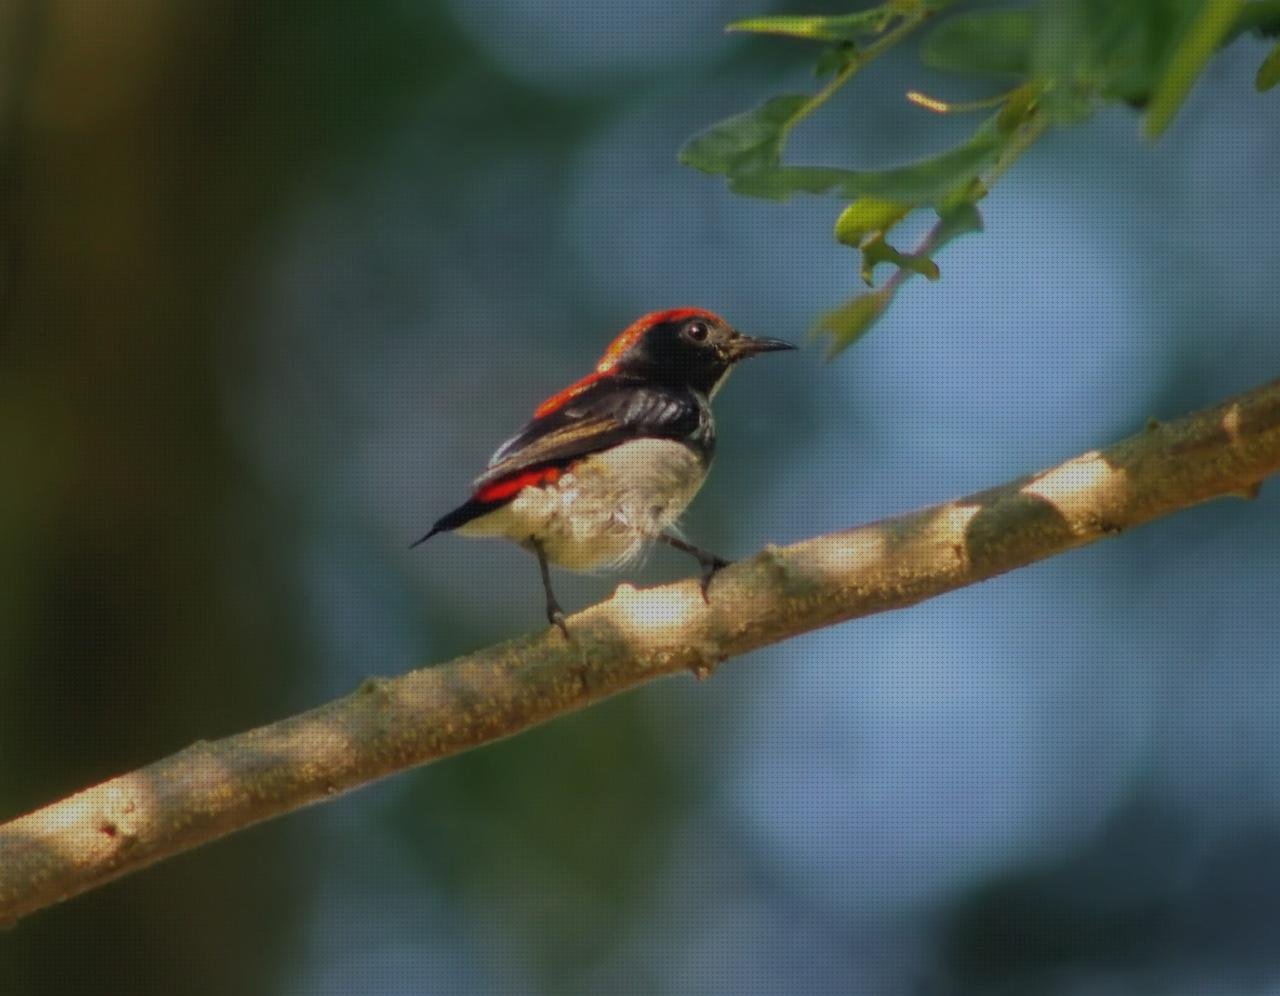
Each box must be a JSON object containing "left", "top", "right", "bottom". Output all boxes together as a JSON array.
[{"left": 411, "top": 307, "right": 795, "bottom": 639}]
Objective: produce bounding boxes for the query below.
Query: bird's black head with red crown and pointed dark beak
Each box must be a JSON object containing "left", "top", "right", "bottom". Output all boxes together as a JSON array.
[{"left": 595, "top": 307, "right": 795, "bottom": 397}]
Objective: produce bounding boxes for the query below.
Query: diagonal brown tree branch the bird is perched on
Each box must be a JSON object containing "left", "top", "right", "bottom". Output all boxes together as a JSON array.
[{"left": 0, "top": 380, "right": 1280, "bottom": 922}]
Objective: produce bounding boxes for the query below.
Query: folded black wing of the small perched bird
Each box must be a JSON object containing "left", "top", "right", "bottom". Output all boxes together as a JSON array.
[{"left": 474, "top": 378, "right": 705, "bottom": 494}]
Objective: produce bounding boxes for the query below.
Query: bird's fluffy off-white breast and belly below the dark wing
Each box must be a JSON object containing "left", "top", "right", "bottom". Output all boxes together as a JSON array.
[{"left": 458, "top": 439, "right": 707, "bottom": 571}]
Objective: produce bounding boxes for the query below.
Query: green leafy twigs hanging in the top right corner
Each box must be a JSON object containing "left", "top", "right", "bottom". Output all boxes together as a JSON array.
[{"left": 680, "top": 0, "right": 1280, "bottom": 353}]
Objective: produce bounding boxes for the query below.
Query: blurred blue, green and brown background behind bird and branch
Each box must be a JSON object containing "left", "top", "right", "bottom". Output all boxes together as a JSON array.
[{"left": 0, "top": 0, "right": 1280, "bottom": 996}]
